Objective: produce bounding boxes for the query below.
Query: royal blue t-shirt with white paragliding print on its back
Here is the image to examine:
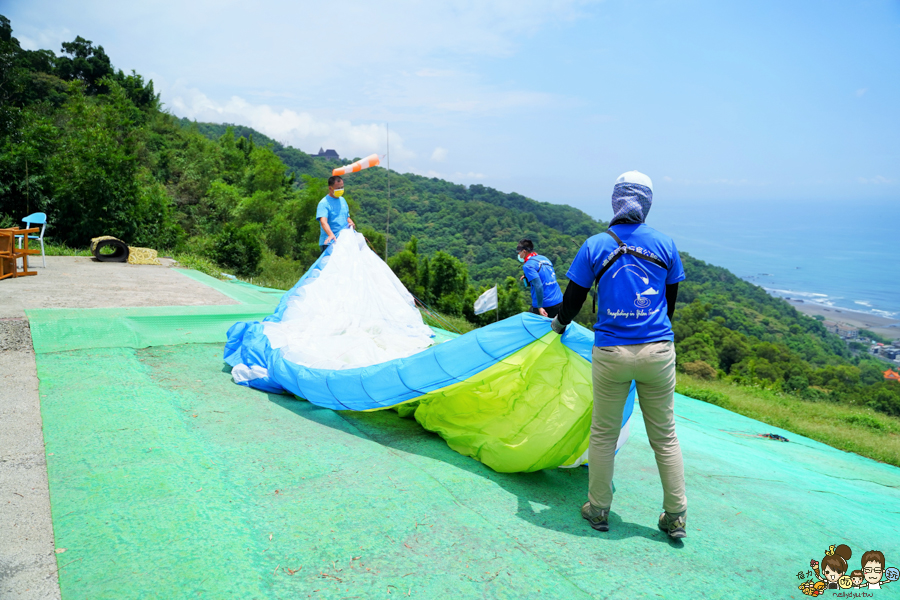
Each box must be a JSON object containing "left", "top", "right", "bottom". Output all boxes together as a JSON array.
[{"left": 566, "top": 223, "right": 684, "bottom": 346}]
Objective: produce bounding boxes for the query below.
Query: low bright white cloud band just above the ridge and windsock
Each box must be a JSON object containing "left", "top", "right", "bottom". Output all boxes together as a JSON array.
[{"left": 169, "top": 89, "right": 415, "bottom": 159}]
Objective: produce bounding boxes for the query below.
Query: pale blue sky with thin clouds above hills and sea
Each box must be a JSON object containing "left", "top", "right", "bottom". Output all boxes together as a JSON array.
[{"left": 0, "top": 0, "right": 900, "bottom": 217}]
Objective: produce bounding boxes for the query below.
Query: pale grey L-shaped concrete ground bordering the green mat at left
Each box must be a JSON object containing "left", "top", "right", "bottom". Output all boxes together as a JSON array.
[{"left": 0, "top": 256, "right": 238, "bottom": 600}]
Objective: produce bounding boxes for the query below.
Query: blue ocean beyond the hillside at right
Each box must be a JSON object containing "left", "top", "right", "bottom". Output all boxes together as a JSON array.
[{"left": 640, "top": 198, "right": 900, "bottom": 318}]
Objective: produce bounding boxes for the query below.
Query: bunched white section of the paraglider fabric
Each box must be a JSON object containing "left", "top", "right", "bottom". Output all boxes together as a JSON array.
[{"left": 263, "top": 228, "right": 434, "bottom": 370}]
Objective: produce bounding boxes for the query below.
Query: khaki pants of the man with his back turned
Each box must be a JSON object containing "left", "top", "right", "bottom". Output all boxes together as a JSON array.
[{"left": 588, "top": 341, "right": 687, "bottom": 514}]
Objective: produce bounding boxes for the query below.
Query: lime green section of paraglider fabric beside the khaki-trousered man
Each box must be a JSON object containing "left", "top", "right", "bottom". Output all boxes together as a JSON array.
[{"left": 414, "top": 333, "right": 592, "bottom": 473}]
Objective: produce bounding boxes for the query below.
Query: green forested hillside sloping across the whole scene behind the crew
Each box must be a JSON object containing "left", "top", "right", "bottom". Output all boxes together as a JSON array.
[{"left": 0, "top": 17, "right": 900, "bottom": 415}]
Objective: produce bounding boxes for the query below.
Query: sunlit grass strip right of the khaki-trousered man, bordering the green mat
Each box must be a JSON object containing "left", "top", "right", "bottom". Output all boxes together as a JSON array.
[{"left": 675, "top": 373, "right": 900, "bottom": 467}]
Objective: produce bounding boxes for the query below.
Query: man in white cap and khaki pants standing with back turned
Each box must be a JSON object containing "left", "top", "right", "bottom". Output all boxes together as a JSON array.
[{"left": 552, "top": 171, "right": 687, "bottom": 539}]
